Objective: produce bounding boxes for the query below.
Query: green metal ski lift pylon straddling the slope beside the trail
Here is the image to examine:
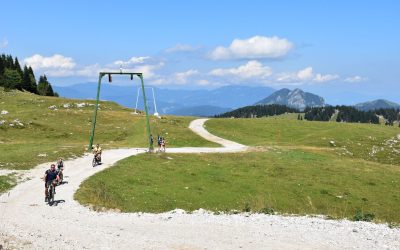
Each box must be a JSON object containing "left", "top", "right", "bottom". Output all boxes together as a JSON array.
[{"left": 88, "top": 71, "right": 154, "bottom": 152}]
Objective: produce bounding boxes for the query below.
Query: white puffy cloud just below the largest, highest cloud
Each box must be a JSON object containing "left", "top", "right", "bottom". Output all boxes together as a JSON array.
[{"left": 209, "top": 60, "right": 272, "bottom": 79}]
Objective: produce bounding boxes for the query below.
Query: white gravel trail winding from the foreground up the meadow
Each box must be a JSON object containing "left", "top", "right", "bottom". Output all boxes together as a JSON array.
[{"left": 0, "top": 119, "right": 400, "bottom": 249}]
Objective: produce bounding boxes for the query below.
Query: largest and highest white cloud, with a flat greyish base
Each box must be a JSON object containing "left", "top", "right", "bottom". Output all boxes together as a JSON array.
[{"left": 210, "top": 36, "right": 293, "bottom": 60}]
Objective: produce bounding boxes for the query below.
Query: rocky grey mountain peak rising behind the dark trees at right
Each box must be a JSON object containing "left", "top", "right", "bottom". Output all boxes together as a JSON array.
[{"left": 255, "top": 89, "right": 325, "bottom": 110}]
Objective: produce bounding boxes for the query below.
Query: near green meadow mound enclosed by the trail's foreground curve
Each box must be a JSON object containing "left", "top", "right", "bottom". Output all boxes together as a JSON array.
[{"left": 76, "top": 150, "right": 400, "bottom": 222}]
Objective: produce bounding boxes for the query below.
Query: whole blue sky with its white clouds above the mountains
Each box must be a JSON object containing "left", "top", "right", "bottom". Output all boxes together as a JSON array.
[{"left": 0, "top": 0, "right": 400, "bottom": 104}]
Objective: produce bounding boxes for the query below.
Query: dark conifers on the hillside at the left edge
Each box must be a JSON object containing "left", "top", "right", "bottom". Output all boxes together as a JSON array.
[{"left": 0, "top": 54, "right": 58, "bottom": 96}]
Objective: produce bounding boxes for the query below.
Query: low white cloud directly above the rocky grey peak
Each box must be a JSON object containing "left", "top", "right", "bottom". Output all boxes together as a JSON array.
[{"left": 276, "top": 67, "right": 339, "bottom": 83}]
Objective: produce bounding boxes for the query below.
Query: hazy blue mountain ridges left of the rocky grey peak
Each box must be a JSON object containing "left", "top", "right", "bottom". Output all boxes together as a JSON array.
[{"left": 54, "top": 83, "right": 275, "bottom": 116}]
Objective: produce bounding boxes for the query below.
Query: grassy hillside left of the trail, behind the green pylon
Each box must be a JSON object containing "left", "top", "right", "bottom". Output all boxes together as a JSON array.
[{"left": 0, "top": 89, "right": 217, "bottom": 169}]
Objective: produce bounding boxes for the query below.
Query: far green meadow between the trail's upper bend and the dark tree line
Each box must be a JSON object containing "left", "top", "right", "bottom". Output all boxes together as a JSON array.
[{"left": 206, "top": 118, "right": 400, "bottom": 165}]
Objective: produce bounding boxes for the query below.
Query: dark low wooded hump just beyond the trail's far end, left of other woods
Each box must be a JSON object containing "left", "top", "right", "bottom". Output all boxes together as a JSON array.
[{"left": 215, "top": 104, "right": 299, "bottom": 118}]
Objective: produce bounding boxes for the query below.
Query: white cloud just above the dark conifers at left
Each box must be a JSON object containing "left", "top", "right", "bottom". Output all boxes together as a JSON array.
[{"left": 24, "top": 54, "right": 76, "bottom": 71}]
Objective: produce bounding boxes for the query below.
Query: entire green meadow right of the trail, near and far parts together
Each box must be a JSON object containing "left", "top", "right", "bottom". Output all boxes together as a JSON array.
[{"left": 76, "top": 116, "right": 400, "bottom": 223}]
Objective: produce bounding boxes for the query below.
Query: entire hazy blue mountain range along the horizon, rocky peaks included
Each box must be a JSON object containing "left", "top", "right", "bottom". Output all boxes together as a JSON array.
[{"left": 54, "top": 83, "right": 400, "bottom": 116}]
